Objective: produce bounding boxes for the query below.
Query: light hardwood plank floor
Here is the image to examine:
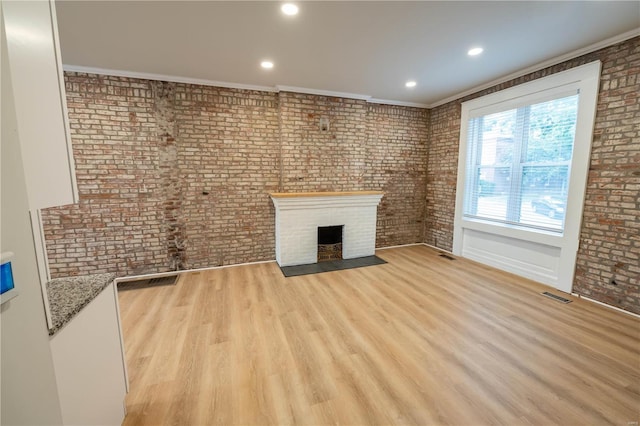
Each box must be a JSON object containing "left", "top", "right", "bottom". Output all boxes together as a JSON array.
[{"left": 119, "top": 246, "right": 640, "bottom": 426}]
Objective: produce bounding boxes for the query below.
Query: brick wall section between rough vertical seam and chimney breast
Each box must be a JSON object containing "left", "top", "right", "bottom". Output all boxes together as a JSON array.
[{"left": 175, "top": 84, "right": 280, "bottom": 268}]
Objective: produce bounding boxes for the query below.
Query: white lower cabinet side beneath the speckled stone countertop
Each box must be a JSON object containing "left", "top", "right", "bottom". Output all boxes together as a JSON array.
[{"left": 50, "top": 283, "right": 127, "bottom": 425}]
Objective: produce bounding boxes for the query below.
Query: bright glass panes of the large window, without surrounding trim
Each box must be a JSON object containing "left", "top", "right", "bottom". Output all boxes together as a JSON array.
[{"left": 464, "top": 94, "right": 579, "bottom": 232}]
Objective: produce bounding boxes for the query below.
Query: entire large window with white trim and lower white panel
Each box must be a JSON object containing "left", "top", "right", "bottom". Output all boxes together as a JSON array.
[{"left": 452, "top": 61, "right": 600, "bottom": 292}]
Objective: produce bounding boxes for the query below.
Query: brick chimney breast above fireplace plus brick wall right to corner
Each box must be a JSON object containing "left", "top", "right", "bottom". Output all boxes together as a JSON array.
[{"left": 280, "top": 92, "right": 429, "bottom": 247}]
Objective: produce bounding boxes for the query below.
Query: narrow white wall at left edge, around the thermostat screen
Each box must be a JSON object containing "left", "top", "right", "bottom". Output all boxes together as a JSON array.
[{"left": 0, "top": 9, "right": 62, "bottom": 425}]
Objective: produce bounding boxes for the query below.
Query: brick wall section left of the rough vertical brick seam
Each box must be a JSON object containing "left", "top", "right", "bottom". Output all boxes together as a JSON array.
[{"left": 42, "top": 74, "right": 169, "bottom": 277}]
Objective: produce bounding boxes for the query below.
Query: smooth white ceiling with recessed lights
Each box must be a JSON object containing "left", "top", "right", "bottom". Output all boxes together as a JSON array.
[{"left": 56, "top": 0, "right": 640, "bottom": 105}]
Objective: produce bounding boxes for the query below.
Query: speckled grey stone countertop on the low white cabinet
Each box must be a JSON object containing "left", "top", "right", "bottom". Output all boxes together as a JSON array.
[{"left": 47, "top": 274, "right": 116, "bottom": 336}]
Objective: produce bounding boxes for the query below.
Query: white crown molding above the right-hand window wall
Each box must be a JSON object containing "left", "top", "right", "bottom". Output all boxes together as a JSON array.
[{"left": 427, "top": 27, "right": 640, "bottom": 109}]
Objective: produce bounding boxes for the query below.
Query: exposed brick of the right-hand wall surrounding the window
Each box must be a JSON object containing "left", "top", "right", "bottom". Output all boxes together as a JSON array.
[{"left": 425, "top": 37, "right": 640, "bottom": 313}]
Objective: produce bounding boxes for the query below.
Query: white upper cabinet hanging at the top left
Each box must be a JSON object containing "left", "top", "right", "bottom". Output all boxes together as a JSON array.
[{"left": 2, "top": 0, "right": 78, "bottom": 210}]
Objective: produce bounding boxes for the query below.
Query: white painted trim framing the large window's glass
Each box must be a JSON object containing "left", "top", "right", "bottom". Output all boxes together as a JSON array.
[{"left": 453, "top": 61, "right": 601, "bottom": 292}]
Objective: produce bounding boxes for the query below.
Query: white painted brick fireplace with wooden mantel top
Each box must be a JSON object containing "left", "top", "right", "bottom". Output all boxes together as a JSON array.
[{"left": 270, "top": 191, "right": 384, "bottom": 266}]
